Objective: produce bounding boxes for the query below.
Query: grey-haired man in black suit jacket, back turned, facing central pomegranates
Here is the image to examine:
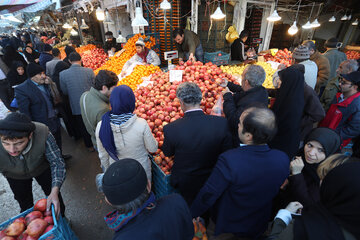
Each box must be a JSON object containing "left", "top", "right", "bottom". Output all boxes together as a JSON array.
[{"left": 162, "top": 82, "right": 232, "bottom": 205}]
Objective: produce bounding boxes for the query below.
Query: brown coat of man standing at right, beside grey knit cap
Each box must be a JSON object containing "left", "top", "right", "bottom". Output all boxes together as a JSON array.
[{"left": 310, "top": 50, "right": 330, "bottom": 92}]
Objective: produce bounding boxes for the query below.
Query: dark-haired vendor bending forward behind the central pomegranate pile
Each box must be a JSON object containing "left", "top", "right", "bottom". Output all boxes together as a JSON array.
[{"left": 173, "top": 28, "right": 204, "bottom": 62}]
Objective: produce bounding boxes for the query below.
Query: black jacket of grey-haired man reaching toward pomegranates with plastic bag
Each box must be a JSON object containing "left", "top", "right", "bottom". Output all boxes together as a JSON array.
[{"left": 223, "top": 82, "right": 268, "bottom": 143}]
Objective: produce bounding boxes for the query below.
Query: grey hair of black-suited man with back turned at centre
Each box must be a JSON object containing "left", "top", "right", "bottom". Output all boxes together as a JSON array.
[{"left": 176, "top": 82, "right": 202, "bottom": 106}]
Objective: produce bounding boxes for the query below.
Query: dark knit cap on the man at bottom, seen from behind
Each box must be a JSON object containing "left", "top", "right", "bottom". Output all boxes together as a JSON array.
[{"left": 102, "top": 158, "right": 147, "bottom": 205}]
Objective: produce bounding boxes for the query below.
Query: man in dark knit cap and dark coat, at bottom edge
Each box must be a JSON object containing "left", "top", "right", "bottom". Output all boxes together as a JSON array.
[{"left": 100, "top": 158, "right": 194, "bottom": 240}]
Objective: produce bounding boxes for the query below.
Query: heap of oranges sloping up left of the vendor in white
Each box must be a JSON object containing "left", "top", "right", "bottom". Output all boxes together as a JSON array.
[{"left": 94, "top": 34, "right": 155, "bottom": 75}]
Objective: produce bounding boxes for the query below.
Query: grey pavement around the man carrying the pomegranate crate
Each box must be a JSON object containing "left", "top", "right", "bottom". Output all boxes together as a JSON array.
[{"left": 0, "top": 131, "right": 113, "bottom": 240}]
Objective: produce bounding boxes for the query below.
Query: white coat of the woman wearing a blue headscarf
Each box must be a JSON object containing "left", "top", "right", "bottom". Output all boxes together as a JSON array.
[{"left": 95, "top": 115, "right": 158, "bottom": 180}]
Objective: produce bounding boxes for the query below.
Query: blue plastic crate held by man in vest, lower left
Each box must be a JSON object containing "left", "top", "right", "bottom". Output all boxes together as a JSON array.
[{"left": 0, "top": 206, "right": 78, "bottom": 240}]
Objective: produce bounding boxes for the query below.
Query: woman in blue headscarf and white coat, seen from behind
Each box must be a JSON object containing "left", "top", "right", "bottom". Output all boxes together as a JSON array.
[{"left": 95, "top": 85, "right": 158, "bottom": 180}]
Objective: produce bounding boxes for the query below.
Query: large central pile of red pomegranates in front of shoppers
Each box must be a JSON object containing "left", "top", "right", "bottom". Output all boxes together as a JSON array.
[{"left": 135, "top": 61, "right": 235, "bottom": 174}]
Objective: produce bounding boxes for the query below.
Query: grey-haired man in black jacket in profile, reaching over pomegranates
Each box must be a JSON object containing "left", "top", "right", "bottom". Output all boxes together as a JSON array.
[{"left": 223, "top": 65, "right": 268, "bottom": 145}]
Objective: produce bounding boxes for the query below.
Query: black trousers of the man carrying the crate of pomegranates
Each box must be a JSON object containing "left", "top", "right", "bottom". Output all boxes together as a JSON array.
[{"left": 6, "top": 168, "right": 65, "bottom": 216}]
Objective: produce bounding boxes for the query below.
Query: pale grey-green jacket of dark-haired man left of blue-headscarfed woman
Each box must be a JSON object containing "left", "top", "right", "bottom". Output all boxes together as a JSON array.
[{"left": 80, "top": 87, "right": 110, "bottom": 146}]
